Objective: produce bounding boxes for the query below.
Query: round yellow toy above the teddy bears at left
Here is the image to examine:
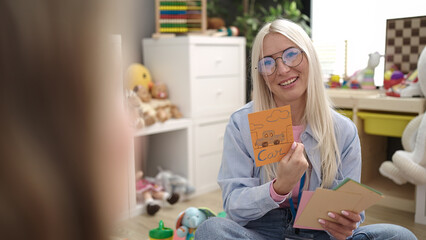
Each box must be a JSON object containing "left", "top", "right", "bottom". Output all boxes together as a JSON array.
[{"left": 127, "top": 63, "right": 152, "bottom": 90}]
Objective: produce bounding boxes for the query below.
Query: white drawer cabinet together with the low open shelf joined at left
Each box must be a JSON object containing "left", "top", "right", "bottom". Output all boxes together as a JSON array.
[{"left": 125, "top": 36, "right": 246, "bottom": 216}]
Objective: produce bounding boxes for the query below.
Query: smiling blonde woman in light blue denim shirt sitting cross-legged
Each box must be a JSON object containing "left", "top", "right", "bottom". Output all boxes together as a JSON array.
[{"left": 196, "top": 19, "right": 416, "bottom": 239}]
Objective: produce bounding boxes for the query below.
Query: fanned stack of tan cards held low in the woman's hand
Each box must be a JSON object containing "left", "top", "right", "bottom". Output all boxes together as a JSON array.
[{"left": 293, "top": 178, "right": 384, "bottom": 230}]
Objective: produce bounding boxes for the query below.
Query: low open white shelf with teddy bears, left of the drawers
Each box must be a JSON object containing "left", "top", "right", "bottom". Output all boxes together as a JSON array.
[{"left": 129, "top": 118, "right": 193, "bottom": 216}]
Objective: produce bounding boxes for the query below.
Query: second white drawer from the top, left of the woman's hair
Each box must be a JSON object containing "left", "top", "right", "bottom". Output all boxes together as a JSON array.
[{"left": 193, "top": 77, "right": 244, "bottom": 117}]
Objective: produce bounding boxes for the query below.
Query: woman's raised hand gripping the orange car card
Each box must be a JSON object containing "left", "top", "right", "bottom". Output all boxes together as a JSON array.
[{"left": 273, "top": 142, "right": 309, "bottom": 195}]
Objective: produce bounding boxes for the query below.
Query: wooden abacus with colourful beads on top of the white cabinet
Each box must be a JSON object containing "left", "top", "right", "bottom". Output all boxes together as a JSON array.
[{"left": 153, "top": 0, "right": 207, "bottom": 37}]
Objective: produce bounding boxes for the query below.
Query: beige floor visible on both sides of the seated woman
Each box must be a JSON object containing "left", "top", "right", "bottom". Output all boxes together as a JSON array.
[{"left": 115, "top": 191, "right": 426, "bottom": 240}]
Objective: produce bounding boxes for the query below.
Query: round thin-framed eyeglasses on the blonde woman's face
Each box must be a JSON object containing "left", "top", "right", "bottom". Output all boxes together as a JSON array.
[{"left": 257, "top": 47, "right": 303, "bottom": 76}]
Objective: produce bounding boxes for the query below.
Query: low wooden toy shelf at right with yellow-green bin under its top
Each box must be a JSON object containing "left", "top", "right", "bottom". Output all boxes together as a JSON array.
[{"left": 327, "top": 89, "right": 426, "bottom": 224}]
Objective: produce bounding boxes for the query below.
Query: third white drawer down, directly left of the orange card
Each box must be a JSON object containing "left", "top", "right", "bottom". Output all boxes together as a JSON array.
[{"left": 195, "top": 120, "right": 228, "bottom": 156}]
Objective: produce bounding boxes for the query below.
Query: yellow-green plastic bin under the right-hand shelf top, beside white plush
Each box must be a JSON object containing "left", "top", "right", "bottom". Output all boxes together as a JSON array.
[{"left": 357, "top": 112, "right": 415, "bottom": 137}]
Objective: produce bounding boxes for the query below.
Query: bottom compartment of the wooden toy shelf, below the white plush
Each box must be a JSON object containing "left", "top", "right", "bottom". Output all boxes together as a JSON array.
[{"left": 363, "top": 175, "right": 415, "bottom": 212}]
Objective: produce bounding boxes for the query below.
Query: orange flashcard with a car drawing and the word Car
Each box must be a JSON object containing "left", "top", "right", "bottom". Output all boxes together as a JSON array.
[{"left": 248, "top": 105, "right": 294, "bottom": 167}]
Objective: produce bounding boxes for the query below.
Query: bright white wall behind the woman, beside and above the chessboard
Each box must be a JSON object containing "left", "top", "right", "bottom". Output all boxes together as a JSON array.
[{"left": 311, "top": 0, "right": 426, "bottom": 85}]
